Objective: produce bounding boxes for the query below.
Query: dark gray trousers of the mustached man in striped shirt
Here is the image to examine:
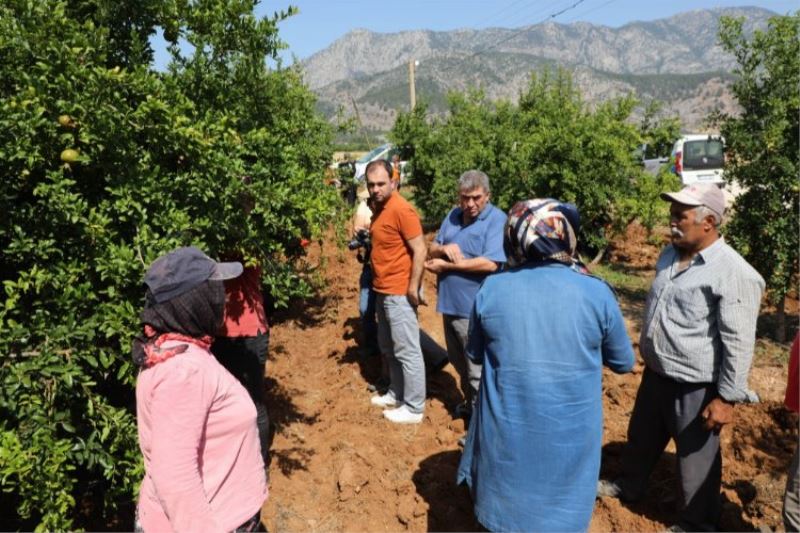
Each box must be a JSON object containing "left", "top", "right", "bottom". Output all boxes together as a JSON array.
[{"left": 622, "top": 369, "right": 722, "bottom": 531}]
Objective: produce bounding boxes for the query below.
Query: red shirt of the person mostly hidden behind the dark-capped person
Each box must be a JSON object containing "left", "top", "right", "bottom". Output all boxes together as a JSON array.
[{"left": 219, "top": 267, "right": 269, "bottom": 337}]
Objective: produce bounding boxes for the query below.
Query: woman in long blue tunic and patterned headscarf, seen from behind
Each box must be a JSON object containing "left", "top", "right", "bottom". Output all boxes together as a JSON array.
[{"left": 458, "top": 199, "right": 634, "bottom": 531}]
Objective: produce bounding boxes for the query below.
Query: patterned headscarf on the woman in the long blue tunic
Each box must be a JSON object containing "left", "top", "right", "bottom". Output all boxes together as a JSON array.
[{"left": 503, "top": 198, "right": 580, "bottom": 267}]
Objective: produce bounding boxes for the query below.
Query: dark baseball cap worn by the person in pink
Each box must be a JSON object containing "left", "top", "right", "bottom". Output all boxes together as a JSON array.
[{"left": 144, "top": 246, "right": 243, "bottom": 303}]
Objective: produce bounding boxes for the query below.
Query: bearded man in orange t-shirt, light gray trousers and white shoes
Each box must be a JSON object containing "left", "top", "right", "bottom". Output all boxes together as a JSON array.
[{"left": 365, "top": 159, "right": 427, "bottom": 424}]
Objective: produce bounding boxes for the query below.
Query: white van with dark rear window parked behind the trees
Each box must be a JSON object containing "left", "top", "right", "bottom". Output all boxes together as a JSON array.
[{"left": 672, "top": 134, "right": 725, "bottom": 187}]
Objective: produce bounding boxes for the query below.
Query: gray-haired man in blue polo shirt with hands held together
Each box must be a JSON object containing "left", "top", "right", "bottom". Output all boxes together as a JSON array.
[{"left": 425, "top": 170, "right": 507, "bottom": 419}]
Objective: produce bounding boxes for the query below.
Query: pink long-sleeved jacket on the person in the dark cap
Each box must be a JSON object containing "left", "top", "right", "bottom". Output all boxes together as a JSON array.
[{"left": 136, "top": 341, "right": 268, "bottom": 533}]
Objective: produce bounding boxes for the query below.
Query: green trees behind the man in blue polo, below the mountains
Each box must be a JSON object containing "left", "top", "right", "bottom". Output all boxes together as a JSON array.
[{"left": 391, "top": 68, "right": 679, "bottom": 250}]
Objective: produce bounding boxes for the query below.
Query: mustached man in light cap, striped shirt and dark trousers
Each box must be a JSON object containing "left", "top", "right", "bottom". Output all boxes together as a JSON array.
[{"left": 598, "top": 184, "right": 764, "bottom": 531}]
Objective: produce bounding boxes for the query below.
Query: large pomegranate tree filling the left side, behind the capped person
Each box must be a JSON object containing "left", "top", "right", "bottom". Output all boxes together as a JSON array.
[{"left": 0, "top": 0, "right": 339, "bottom": 530}]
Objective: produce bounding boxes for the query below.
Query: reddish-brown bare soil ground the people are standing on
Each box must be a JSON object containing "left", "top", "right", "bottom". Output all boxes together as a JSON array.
[{"left": 264, "top": 227, "right": 797, "bottom": 533}]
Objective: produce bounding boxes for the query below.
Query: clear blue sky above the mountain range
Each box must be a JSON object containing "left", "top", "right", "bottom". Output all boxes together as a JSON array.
[{"left": 154, "top": 0, "right": 800, "bottom": 68}]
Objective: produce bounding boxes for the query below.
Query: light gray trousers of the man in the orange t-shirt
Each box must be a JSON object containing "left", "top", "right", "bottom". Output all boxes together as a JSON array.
[{"left": 375, "top": 293, "right": 425, "bottom": 413}]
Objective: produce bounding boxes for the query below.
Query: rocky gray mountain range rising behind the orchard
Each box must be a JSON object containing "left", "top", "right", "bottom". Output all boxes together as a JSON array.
[{"left": 302, "top": 7, "right": 775, "bottom": 131}]
